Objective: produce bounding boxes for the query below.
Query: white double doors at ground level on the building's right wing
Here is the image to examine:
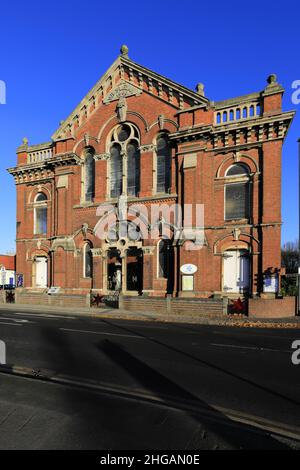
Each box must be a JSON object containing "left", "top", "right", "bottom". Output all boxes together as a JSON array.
[{"left": 223, "top": 250, "right": 250, "bottom": 294}]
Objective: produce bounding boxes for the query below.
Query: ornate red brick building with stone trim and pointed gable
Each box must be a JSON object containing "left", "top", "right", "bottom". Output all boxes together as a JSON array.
[{"left": 9, "top": 46, "right": 294, "bottom": 304}]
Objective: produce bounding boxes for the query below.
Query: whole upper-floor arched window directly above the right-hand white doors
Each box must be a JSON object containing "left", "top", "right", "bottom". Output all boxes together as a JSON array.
[{"left": 225, "top": 163, "right": 250, "bottom": 220}]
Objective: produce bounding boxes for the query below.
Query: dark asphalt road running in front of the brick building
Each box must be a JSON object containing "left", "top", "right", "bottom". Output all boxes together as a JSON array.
[{"left": 0, "top": 310, "right": 300, "bottom": 449}]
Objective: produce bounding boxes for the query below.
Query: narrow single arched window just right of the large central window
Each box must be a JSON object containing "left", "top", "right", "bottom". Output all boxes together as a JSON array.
[{"left": 156, "top": 134, "right": 171, "bottom": 193}]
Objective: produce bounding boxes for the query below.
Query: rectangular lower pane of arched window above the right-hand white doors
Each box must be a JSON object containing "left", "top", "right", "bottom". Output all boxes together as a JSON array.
[{"left": 225, "top": 183, "right": 249, "bottom": 220}]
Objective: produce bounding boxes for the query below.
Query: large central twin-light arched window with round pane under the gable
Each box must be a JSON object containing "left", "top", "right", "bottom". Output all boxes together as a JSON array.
[{"left": 109, "top": 123, "right": 140, "bottom": 197}]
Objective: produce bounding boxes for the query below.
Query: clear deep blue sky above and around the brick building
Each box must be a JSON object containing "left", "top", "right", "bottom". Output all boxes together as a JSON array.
[{"left": 0, "top": 0, "right": 300, "bottom": 253}]
